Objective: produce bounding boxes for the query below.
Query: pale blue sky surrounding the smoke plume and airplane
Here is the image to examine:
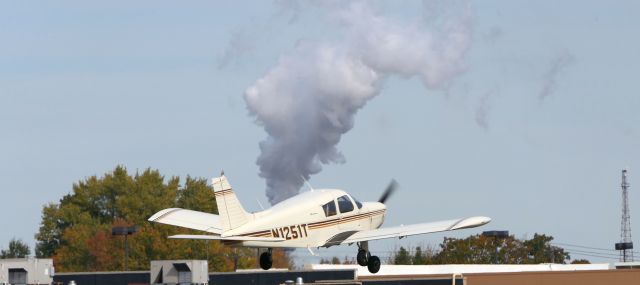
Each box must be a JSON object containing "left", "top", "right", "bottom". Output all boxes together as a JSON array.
[{"left": 0, "top": 1, "right": 640, "bottom": 261}]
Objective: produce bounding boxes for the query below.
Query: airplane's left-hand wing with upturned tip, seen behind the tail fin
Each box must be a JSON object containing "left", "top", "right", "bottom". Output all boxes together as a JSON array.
[{"left": 149, "top": 208, "right": 222, "bottom": 235}]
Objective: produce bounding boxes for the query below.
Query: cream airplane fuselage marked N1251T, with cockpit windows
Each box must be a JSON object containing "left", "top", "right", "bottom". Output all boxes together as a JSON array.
[{"left": 223, "top": 189, "right": 386, "bottom": 248}]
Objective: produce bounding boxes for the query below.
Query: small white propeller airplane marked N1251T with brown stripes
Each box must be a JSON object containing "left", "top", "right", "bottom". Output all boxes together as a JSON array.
[{"left": 149, "top": 173, "right": 491, "bottom": 273}]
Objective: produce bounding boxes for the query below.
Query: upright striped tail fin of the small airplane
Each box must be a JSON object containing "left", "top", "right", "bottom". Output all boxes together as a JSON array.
[{"left": 213, "top": 174, "right": 249, "bottom": 231}]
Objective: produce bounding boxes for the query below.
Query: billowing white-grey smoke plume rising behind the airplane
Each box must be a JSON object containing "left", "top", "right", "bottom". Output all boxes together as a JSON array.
[{"left": 245, "top": 2, "right": 471, "bottom": 204}]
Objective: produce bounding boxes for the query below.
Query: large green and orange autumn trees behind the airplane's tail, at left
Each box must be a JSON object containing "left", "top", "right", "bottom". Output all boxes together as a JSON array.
[{"left": 36, "top": 166, "right": 291, "bottom": 272}]
